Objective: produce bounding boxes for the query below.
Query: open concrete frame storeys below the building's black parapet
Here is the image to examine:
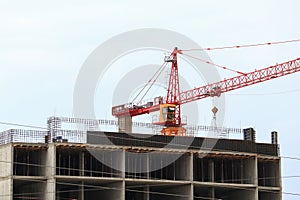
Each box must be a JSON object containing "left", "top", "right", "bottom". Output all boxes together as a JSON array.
[{"left": 0, "top": 143, "right": 281, "bottom": 200}]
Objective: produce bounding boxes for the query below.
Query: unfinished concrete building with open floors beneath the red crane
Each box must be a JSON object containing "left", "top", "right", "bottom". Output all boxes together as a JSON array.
[{"left": 0, "top": 117, "right": 282, "bottom": 200}]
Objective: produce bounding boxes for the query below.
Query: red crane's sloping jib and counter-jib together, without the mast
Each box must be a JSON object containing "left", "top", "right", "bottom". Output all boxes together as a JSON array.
[{"left": 112, "top": 58, "right": 300, "bottom": 117}]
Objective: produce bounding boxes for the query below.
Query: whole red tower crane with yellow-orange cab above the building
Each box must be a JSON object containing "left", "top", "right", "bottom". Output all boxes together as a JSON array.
[{"left": 112, "top": 48, "right": 300, "bottom": 136}]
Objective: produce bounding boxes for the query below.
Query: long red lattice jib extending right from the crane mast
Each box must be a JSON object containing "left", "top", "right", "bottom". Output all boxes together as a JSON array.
[{"left": 179, "top": 58, "right": 300, "bottom": 104}]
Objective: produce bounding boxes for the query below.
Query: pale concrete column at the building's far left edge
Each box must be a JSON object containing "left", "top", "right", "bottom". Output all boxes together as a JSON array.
[{"left": 0, "top": 143, "right": 13, "bottom": 200}]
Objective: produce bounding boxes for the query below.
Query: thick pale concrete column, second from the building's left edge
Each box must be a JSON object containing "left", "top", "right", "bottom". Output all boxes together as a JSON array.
[{"left": 44, "top": 143, "right": 56, "bottom": 200}]
